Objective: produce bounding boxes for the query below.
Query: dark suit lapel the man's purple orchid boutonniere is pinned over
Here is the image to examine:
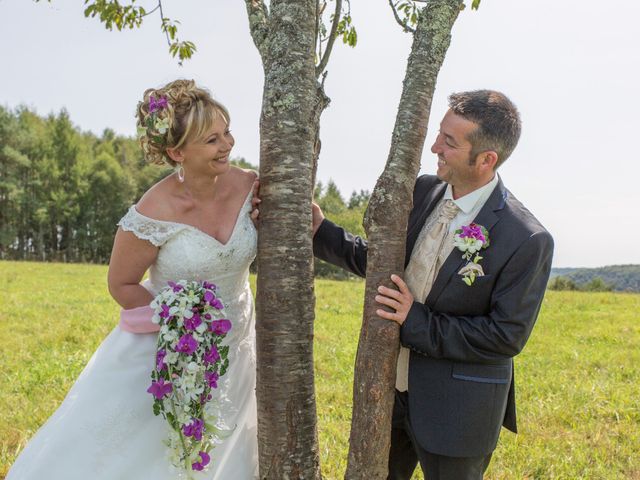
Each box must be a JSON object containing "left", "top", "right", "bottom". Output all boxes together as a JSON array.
[{"left": 425, "top": 179, "right": 507, "bottom": 305}]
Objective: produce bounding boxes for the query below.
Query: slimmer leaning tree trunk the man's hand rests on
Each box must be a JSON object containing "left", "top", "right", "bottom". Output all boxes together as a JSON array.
[{"left": 345, "top": 0, "right": 462, "bottom": 480}]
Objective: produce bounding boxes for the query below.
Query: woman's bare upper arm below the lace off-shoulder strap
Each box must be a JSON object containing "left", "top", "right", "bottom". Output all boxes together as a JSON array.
[{"left": 108, "top": 228, "right": 158, "bottom": 310}]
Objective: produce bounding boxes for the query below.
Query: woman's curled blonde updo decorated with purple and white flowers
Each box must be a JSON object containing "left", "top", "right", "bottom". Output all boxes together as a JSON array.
[{"left": 136, "top": 80, "right": 230, "bottom": 167}]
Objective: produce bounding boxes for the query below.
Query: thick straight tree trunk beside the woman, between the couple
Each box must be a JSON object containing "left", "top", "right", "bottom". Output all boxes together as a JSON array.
[{"left": 246, "top": 0, "right": 320, "bottom": 480}]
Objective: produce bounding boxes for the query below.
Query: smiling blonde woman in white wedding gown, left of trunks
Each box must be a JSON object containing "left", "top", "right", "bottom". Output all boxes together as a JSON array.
[{"left": 7, "top": 80, "right": 258, "bottom": 480}]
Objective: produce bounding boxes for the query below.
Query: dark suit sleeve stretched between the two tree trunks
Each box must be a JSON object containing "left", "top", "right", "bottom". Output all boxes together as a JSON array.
[{"left": 313, "top": 219, "right": 367, "bottom": 277}]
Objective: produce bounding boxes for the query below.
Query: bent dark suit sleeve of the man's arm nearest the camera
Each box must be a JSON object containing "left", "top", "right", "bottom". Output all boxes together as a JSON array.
[{"left": 400, "top": 231, "right": 553, "bottom": 363}]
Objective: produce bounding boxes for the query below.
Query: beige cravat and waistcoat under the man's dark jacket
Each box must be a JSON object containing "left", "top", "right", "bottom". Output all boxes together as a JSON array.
[{"left": 396, "top": 200, "right": 460, "bottom": 392}]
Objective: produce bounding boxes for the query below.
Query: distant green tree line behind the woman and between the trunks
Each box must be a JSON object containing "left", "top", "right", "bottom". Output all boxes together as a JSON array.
[{"left": 0, "top": 106, "right": 369, "bottom": 270}]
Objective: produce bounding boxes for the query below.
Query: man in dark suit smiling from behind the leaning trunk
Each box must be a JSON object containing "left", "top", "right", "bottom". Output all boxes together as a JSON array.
[{"left": 313, "top": 90, "right": 553, "bottom": 480}]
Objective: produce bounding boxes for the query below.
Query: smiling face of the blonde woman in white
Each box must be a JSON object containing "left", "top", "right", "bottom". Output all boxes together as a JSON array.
[{"left": 181, "top": 115, "right": 235, "bottom": 175}]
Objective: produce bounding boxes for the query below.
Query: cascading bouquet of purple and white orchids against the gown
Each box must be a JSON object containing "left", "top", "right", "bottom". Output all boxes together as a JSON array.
[{"left": 147, "top": 280, "right": 231, "bottom": 476}]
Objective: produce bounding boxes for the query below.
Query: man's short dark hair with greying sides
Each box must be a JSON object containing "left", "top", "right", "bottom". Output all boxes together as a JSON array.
[{"left": 449, "top": 90, "right": 522, "bottom": 168}]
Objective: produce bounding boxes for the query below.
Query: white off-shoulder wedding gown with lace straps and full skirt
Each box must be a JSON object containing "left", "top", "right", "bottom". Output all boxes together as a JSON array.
[{"left": 7, "top": 194, "right": 258, "bottom": 480}]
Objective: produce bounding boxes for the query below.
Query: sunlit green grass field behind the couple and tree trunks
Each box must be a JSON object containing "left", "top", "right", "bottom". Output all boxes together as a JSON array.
[{"left": 0, "top": 262, "right": 640, "bottom": 480}]
